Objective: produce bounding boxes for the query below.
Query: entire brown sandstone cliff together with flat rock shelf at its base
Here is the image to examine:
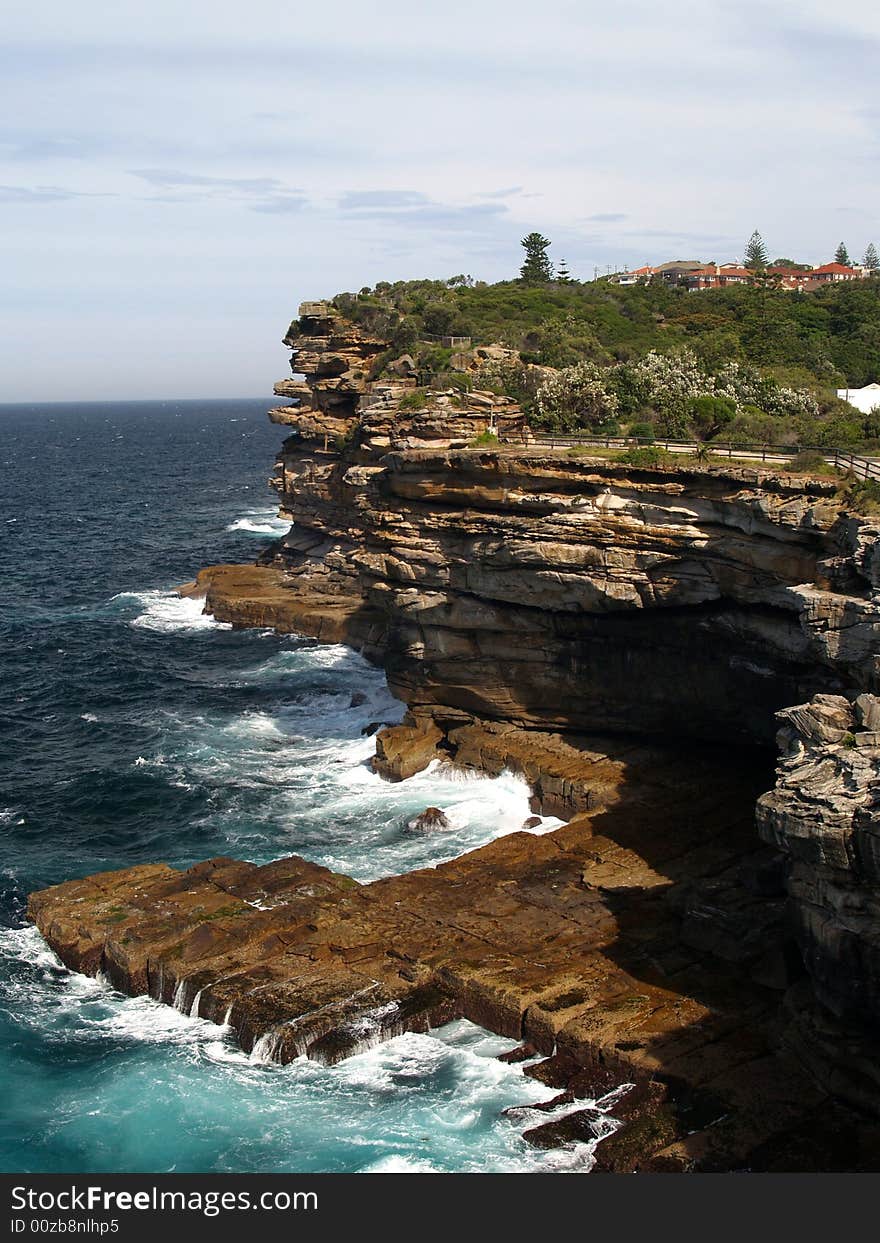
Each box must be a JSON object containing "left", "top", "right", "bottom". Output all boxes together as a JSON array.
[{"left": 25, "top": 303, "right": 880, "bottom": 1168}]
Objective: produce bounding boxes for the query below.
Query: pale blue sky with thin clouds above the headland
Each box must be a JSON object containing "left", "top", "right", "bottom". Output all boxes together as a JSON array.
[{"left": 0, "top": 0, "right": 880, "bottom": 401}]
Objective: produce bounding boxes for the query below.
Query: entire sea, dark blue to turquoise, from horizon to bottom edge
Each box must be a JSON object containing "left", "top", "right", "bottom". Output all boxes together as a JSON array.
[{"left": 0, "top": 401, "right": 599, "bottom": 1171}]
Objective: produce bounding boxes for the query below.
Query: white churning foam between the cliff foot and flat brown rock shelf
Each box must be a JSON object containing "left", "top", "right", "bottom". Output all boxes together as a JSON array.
[{"left": 118, "top": 640, "right": 561, "bottom": 880}]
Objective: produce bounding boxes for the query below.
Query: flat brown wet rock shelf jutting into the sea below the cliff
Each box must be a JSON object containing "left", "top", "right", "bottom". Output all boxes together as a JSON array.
[{"left": 30, "top": 747, "right": 873, "bottom": 1170}]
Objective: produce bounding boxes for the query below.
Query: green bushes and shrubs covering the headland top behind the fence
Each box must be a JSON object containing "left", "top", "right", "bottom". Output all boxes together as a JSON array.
[{"left": 334, "top": 267, "right": 880, "bottom": 449}]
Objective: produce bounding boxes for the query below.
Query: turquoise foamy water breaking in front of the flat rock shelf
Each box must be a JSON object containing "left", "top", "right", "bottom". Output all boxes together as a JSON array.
[{"left": 0, "top": 929, "right": 614, "bottom": 1173}]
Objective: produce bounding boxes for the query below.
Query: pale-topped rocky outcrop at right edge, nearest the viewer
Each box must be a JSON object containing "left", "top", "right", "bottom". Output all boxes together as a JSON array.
[{"left": 757, "top": 694, "right": 880, "bottom": 1111}]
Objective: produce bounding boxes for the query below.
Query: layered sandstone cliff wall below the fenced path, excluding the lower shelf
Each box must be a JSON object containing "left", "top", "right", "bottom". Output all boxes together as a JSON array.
[{"left": 256, "top": 307, "right": 880, "bottom": 743}]
